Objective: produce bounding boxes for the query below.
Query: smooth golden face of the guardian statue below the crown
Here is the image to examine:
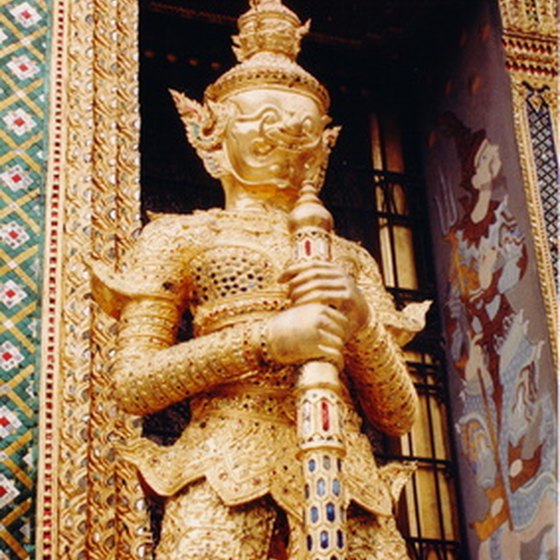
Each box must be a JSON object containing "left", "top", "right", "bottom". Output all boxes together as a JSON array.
[{"left": 224, "top": 88, "right": 329, "bottom": 201}]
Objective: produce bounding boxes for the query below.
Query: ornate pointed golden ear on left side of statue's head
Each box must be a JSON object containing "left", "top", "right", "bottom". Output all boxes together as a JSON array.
[{"left": 169, "top": 89, "right": 233, "bottom": 178}]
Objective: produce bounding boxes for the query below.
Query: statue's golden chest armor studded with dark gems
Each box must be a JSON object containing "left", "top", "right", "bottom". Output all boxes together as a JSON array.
[{"left": 189, "top": 223, "right": 291, "bottom": 334}]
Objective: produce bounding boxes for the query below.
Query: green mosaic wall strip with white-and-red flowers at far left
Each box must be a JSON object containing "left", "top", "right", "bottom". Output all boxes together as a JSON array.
[{"left": 0, "top": 0, "right": 49, "bottom": 560}]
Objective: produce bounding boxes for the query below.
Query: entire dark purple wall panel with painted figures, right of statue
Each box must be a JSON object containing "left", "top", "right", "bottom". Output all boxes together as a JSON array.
[{"left": 424, "top": 2, "right": 557, "bottom": 560}]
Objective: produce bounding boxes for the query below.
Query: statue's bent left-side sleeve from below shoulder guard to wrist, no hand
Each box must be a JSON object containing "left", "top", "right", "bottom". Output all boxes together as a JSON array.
[{"left": 114, "top": 298, "right": 263, "bottom": 414}]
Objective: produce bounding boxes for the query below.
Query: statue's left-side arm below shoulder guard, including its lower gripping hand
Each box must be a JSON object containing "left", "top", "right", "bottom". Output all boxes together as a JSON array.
[{"left": 110, "top": 296, "right": 346, "bottom": 414}]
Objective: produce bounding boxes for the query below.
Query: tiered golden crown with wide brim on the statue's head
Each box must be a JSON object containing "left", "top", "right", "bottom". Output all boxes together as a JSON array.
[{"left": 205, "top": 0, "right": 330, "bottom": 112}]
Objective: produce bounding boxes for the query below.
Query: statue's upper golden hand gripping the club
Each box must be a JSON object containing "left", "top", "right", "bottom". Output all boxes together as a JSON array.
[{"left": 280, "top": 261, "right": 370, "bottom": 337}]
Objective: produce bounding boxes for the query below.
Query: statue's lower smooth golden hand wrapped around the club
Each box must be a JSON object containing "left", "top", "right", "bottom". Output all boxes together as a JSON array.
[{"left": 265, "top": 303, "right": 348, "bottom": 367}]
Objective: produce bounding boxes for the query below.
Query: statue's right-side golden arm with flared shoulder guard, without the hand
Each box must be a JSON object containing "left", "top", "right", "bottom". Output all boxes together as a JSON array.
[{"left": 345, "top": 249, "right": 427, "bottom": 436}]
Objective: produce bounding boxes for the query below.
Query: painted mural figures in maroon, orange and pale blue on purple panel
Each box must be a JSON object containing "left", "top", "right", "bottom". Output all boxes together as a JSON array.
[{"left": 437, "top": 113, "right": 556, "bottom": 560}]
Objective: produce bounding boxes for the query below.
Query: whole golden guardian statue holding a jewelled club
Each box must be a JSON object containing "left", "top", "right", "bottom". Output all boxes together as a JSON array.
[{"left": 94, "top": 0, "right": 426, "bottom": 560}]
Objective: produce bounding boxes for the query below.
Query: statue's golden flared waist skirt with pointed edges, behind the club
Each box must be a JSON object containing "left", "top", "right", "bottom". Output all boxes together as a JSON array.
[{"left": 124, "top": 372, "right": 392, "bottom": 517}]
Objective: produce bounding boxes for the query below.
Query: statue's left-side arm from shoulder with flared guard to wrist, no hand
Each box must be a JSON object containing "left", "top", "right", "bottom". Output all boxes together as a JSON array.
[{"left": 92, "top": 219, "right": 264, "bottom": 414}]
